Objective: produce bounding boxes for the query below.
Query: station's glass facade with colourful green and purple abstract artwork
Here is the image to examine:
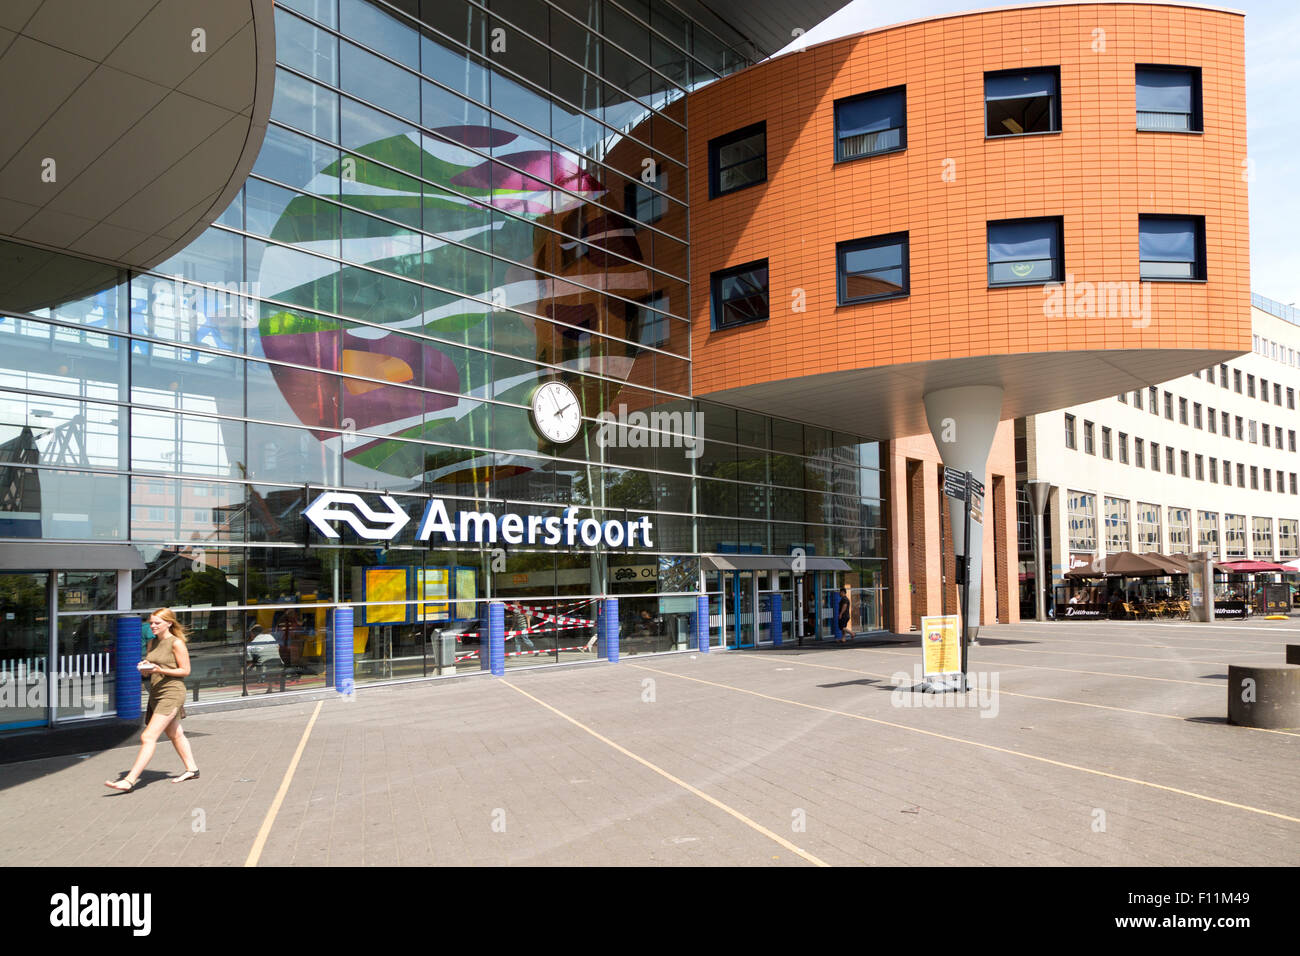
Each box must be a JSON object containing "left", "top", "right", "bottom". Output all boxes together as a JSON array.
[{"left": 0, "top": 0, "right": 888, "bottom": 717}]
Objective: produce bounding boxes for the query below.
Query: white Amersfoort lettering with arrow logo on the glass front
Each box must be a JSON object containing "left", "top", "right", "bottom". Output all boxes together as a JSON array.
[{"left": 303, "top": 492, "right": 654, "bottom": 548}]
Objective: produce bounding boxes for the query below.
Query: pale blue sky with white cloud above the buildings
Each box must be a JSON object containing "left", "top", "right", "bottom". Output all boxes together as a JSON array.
[{"left": 774, "top": 0, "right": 1300, "bottom": 304}]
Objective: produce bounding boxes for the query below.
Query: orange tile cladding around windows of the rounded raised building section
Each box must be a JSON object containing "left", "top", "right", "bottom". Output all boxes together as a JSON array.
[{"left": 689, "top": 4, "right": 1251, "bottom": 395}]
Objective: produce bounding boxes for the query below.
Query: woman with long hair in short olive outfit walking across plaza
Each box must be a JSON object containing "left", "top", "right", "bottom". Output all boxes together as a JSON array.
[{"left": 104, "top": 607, "right": 199, "bottom": 793}]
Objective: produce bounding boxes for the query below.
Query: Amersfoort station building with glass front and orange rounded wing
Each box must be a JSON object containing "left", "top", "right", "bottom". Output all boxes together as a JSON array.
[{"left": 0, "top": 0, "right": 1251, "bottom": 727}]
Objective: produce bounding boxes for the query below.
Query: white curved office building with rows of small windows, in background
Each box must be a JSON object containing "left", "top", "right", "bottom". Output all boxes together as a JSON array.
[{"left": 1015, "top": 295, "right": 1300, "bottom": 602}]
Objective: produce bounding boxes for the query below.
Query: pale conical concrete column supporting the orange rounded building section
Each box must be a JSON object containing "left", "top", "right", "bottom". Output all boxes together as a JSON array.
[{"left": 924, "top": 385, "right": 1002, "bottom": 630}]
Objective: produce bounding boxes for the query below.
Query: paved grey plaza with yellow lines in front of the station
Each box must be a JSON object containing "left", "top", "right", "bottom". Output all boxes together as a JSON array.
[{"left": 0, "top": 619, "right": 1300, "bottom": 866}]
